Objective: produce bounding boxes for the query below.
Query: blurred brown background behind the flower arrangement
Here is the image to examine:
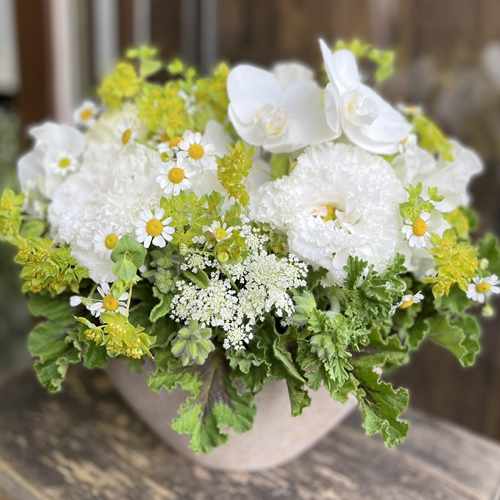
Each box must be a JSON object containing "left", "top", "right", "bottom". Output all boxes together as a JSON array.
[{"left": 0, "top": 0, "right": 500, "bottom": 440}]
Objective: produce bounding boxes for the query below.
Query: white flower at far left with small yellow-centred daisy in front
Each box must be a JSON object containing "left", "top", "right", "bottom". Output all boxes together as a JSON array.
[{"left": 17, "top": 122, "right": 85, "bottom": 215}]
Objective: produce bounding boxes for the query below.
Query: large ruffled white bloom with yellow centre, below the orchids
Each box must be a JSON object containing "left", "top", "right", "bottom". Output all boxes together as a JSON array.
[{"left": 250, "top": 144, "right": 405, "bottom": 283}]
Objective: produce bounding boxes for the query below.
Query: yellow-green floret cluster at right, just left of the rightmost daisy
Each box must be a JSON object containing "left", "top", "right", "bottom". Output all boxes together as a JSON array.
[{"left": 426, "top": 229, "right": 479, "bottom": 297}]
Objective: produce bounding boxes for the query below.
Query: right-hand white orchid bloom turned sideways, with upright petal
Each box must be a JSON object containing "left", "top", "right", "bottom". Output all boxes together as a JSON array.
[{"left": 319, "top": 40, "right": 411, "bottom": 154}]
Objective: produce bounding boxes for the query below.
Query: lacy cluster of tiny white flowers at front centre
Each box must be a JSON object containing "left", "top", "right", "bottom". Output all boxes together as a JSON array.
[{"left": 171, "top": 227, "right": 307, "bottom": 350}]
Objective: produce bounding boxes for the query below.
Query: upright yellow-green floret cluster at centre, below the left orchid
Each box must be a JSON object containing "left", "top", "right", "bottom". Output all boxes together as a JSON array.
[{"left": 217, "top": 141, "right": 255, "bottom": 205}]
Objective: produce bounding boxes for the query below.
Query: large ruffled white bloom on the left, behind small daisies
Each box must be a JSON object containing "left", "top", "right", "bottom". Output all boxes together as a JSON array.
[{"left": 49, "top": 144, "right": 162, "bottom": 282}]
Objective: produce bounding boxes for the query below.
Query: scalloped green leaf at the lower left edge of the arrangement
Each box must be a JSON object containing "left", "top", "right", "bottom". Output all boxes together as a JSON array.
[{"left": 28, "top": 295, "right": 81, "bottom": 392}]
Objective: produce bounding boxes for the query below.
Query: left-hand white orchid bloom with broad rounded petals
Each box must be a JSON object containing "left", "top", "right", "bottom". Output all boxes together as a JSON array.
[{"left": 227, "top": 64, "right": 334, "bottom": 153}]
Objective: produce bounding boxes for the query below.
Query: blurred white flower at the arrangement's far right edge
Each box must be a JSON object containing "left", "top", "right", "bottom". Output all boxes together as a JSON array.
[{"left": 394, "top": 140, "right": 483, "bottom": 212}]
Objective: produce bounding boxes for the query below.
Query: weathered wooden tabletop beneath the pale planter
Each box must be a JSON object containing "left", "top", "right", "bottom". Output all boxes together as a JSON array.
[{"left": 0, "top": 371, "right": 500, "bottom": 500}]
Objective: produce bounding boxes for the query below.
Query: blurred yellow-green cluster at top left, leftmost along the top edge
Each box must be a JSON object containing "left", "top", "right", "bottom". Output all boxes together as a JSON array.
[{"left": 98, "top": 61, "right": 141, "bottom": 109}]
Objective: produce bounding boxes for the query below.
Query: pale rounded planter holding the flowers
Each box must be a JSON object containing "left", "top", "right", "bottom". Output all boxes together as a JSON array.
[{"left": 109, "top": 361, "right": 356, "bottom": 471}]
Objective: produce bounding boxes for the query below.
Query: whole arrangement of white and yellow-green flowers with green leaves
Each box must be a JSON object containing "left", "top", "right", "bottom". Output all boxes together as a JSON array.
[{"left": 0, "top": 40, "right": 500, "bottom": 452}]
